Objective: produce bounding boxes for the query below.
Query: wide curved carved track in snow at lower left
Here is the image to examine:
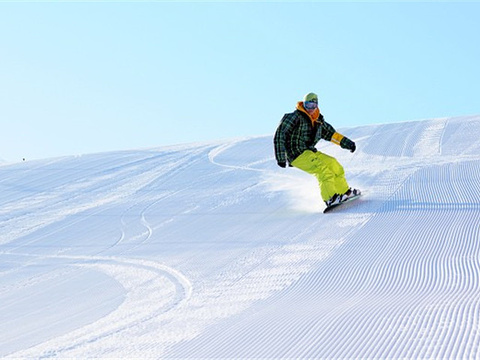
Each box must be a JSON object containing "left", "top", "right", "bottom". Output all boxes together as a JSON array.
[{"left": 4, "top": 254, "right": 192, "bottom": 358}]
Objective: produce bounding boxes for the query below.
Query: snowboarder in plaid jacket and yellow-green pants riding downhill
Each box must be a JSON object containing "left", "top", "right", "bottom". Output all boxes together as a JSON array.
[{"left": 274, "top": 93, "right": 360, "bottom": 207}]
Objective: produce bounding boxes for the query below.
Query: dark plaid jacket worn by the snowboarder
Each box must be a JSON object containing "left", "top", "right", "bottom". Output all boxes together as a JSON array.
[{"left": 273, "top": 109, "right": 343, "bottom": 163}]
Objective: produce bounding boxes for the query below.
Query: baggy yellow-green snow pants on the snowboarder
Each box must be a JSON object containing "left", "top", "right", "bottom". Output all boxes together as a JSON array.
[{"left": 292, "top": 150, "right": 349, "bottom": 201}]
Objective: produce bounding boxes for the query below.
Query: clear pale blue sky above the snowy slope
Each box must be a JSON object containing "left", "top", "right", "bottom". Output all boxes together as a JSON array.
[{"left": 0, "top": 2, "right": 480, "bottom": 162}]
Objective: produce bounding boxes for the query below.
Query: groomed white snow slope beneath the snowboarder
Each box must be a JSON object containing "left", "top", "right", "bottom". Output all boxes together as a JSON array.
[{"left": 0, "top": 116, "right": 480, "bottom": 359}]
